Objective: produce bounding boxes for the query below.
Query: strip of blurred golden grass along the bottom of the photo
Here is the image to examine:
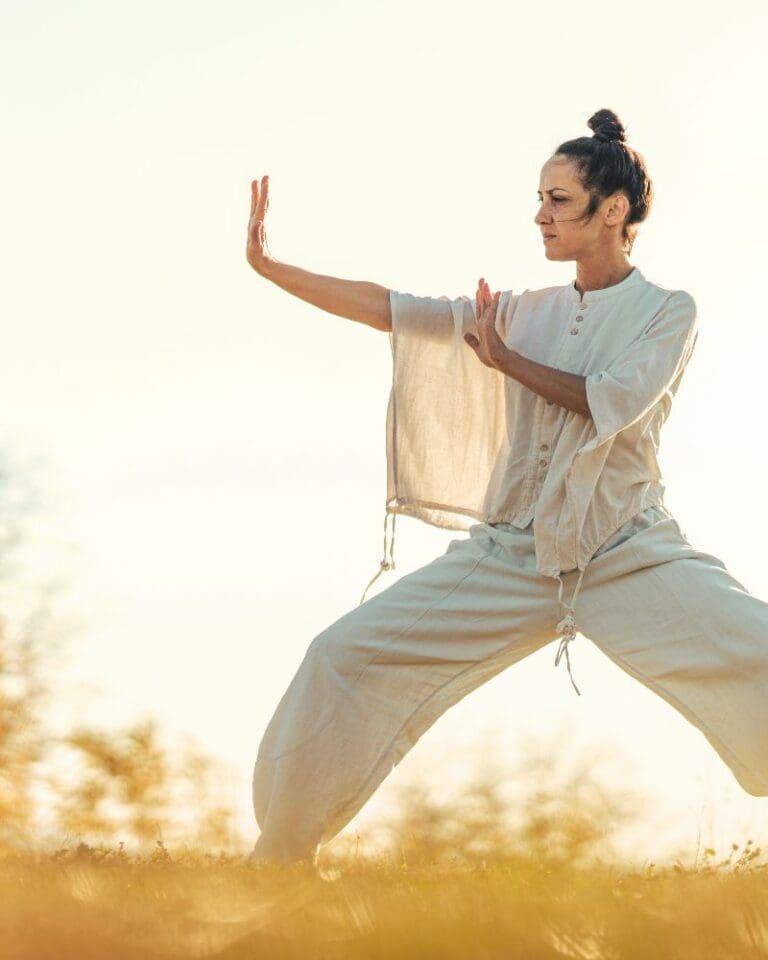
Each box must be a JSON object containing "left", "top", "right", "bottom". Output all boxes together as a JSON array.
[{"left": 0, "top": 842, "right": 768, "bottom": 960}]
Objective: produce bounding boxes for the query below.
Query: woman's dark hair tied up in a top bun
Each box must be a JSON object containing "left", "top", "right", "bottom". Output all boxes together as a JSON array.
[{"left": 554, "top": 110, "right": 653, "bottom": 254}]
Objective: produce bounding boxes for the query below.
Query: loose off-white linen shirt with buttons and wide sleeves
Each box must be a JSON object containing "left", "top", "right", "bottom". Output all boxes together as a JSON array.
[{"left": 363, "top": 267, "right": 698, "bottom": 688}]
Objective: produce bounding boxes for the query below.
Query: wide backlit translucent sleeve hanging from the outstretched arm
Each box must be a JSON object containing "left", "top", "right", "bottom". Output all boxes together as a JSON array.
[{"left": 387, "top": 290, "right": 515, "bottom": 529}]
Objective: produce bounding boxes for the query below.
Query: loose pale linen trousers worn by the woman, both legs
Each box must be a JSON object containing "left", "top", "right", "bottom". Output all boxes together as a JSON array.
[{"left": 251, "top": 505, "right": 768, "bottom": 863}]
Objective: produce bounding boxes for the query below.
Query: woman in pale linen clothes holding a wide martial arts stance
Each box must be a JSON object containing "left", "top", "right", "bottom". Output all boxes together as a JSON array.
[{"left": 247, "top": 110, "right": 768, "bottom": 863}]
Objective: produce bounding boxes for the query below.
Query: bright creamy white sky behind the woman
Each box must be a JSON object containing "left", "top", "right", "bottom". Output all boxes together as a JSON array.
[{"left": 0, "top": 0, "right": 768, "bottom": 854}]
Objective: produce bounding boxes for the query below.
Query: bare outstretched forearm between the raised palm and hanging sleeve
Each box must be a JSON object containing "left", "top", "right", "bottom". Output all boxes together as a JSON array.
[{"left": 260, "top": 260, "right": 392, "bottom": 332}]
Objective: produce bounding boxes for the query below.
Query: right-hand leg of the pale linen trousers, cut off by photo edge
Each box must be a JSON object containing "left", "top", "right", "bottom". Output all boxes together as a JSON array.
[{"left": 578, "top": 515, "right": 768, "bottom": 797}]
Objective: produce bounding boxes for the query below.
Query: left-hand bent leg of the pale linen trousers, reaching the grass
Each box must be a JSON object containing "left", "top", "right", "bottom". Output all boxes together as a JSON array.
[{"left": 252, "top": 524, "right": 559, "bottom": 861}]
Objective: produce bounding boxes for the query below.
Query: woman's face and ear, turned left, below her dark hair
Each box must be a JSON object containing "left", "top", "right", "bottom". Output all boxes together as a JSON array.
[{"left": 534, "top": 154, "right": 626, "bottom": 260}]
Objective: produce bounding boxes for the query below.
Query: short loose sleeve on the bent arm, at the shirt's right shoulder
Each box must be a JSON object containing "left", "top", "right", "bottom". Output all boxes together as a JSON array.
[{"left": 586, "top": 290, "right": 698, "bottom": 444}]
